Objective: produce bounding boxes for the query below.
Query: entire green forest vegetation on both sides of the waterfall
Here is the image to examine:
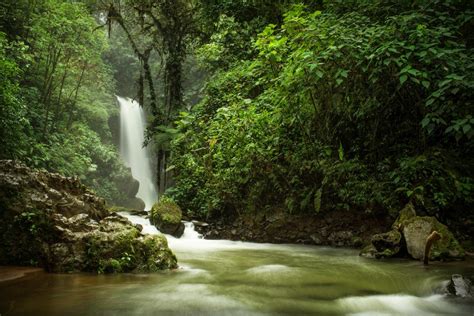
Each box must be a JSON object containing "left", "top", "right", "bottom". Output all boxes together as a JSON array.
[{"left": 0, "top": 0, "right": 474, "bottom": 244}]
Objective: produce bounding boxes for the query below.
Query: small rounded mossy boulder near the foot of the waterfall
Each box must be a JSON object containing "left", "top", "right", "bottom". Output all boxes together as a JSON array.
[{"left": 150, "top": 197, "right": 184, "bottom": 237}]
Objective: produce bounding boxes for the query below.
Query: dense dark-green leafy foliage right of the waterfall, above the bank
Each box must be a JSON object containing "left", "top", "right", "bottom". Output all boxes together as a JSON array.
[{"left": 171, "top": 1, "right": 474, "bottom": 222}]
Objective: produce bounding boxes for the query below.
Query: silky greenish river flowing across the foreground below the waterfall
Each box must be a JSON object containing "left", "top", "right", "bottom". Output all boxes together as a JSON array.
[{"left": 0, "top": 215, "right": 474, "bottom": 316}]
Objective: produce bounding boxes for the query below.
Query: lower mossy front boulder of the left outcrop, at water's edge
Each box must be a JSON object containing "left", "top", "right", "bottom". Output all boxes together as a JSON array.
[{"left": 42, "top": 214, "right": 177, "bottom": 273}]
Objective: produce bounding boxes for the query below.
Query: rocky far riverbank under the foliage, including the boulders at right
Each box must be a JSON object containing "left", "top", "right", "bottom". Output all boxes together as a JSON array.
[{"left": 194, "top": 203, "right": 465, "bottom": 261}]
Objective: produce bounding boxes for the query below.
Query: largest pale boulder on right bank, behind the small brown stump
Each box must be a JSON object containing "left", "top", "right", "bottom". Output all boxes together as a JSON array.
[{"left": 402, "top": 216, "right": 465, "bottom": 260}]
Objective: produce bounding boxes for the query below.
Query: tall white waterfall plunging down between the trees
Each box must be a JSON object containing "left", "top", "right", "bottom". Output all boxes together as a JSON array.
[{"left": 117, "top": 96, "right": 158, "bottom": 210}]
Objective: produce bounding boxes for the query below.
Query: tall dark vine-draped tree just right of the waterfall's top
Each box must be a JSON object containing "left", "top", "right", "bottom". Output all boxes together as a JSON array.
[{"left": 104, "top": 0, "right": 195, "bottom": 191}]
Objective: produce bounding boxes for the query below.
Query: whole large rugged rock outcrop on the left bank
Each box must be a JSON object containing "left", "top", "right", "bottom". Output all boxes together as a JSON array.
[{"left": 0, "top": 161, "right": 177, "bottom": 272}]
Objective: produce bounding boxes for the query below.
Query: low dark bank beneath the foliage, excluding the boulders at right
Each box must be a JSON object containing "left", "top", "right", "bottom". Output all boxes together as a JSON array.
[{"left": 195, "top": 211, "right": 391, "bottom": 248}]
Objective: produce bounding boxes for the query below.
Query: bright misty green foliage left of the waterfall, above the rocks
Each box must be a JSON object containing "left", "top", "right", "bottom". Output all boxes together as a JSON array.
[{"left": 0, "top": 0, "right": 130, "bottom": 205}]
